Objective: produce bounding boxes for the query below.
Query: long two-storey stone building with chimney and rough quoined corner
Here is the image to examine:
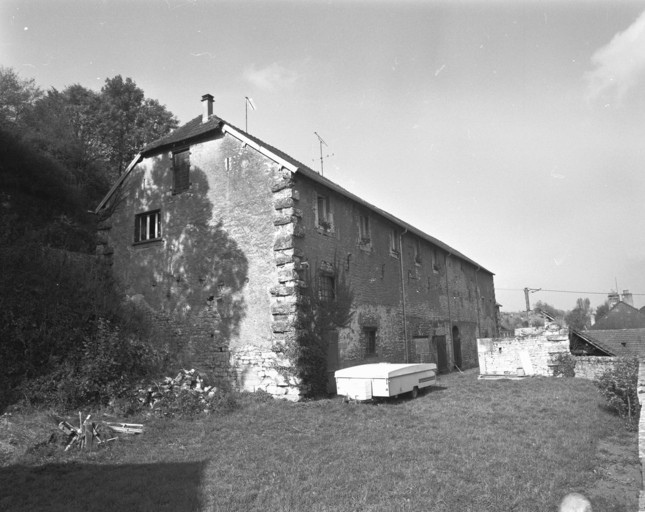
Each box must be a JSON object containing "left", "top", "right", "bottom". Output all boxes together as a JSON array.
[{"left": 96, "top": 95, "right": 498, "bottom": 396}]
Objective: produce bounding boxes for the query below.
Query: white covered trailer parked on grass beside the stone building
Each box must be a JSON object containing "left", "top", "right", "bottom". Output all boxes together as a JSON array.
[{"left": 334, "top": 363, "right": 437, "bottom": 400}]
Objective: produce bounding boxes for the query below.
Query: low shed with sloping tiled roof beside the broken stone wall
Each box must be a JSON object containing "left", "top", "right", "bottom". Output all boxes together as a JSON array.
[{"left": 569, "top": 328, "right": 645, "bottom": 357}]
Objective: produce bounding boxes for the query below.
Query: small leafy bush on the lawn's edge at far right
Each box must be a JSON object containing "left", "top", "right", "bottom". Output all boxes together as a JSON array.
[{"left": 595, "top": 358, "right": 640, "bottom": 428}]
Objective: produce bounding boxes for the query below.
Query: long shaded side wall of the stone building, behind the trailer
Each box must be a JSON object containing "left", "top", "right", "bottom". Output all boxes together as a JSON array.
[{"left": 294, "top": 173, "right": 497, "bottom": 369}]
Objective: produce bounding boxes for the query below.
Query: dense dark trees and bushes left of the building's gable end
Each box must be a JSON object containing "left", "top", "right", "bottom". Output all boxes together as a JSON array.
[{"left": 0, "top": 68, "right": 177, "bottom": 408}]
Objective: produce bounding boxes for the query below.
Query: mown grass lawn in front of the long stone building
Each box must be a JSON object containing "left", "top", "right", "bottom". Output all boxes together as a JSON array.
[{"left": 0, "top": 371, "right": 639, "bottom": 512}]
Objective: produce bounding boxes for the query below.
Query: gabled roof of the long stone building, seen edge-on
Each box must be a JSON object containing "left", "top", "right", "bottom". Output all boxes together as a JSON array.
[{"left": 95, "top": 110, "right": 494, "bottom": 275}]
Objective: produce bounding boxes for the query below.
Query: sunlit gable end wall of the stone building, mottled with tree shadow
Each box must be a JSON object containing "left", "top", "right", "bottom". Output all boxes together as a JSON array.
[{"left": 97, "top": 133, "right": 297, "bottom": 395}]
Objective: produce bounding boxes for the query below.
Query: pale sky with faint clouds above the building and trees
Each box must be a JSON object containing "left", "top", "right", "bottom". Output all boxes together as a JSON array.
[{"left": 0, "top": 0, "right": 645, "bottom": 311}]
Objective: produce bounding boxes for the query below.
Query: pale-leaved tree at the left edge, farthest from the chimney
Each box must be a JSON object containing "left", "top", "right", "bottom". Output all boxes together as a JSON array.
[{"left": 0, "top": 66, "right": 42, "bottom": 129}]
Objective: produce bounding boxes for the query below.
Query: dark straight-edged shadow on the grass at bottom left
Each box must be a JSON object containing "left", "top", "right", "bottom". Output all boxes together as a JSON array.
[{"left": 0, "top": 461, "right": 206, "bottom": 512}]
